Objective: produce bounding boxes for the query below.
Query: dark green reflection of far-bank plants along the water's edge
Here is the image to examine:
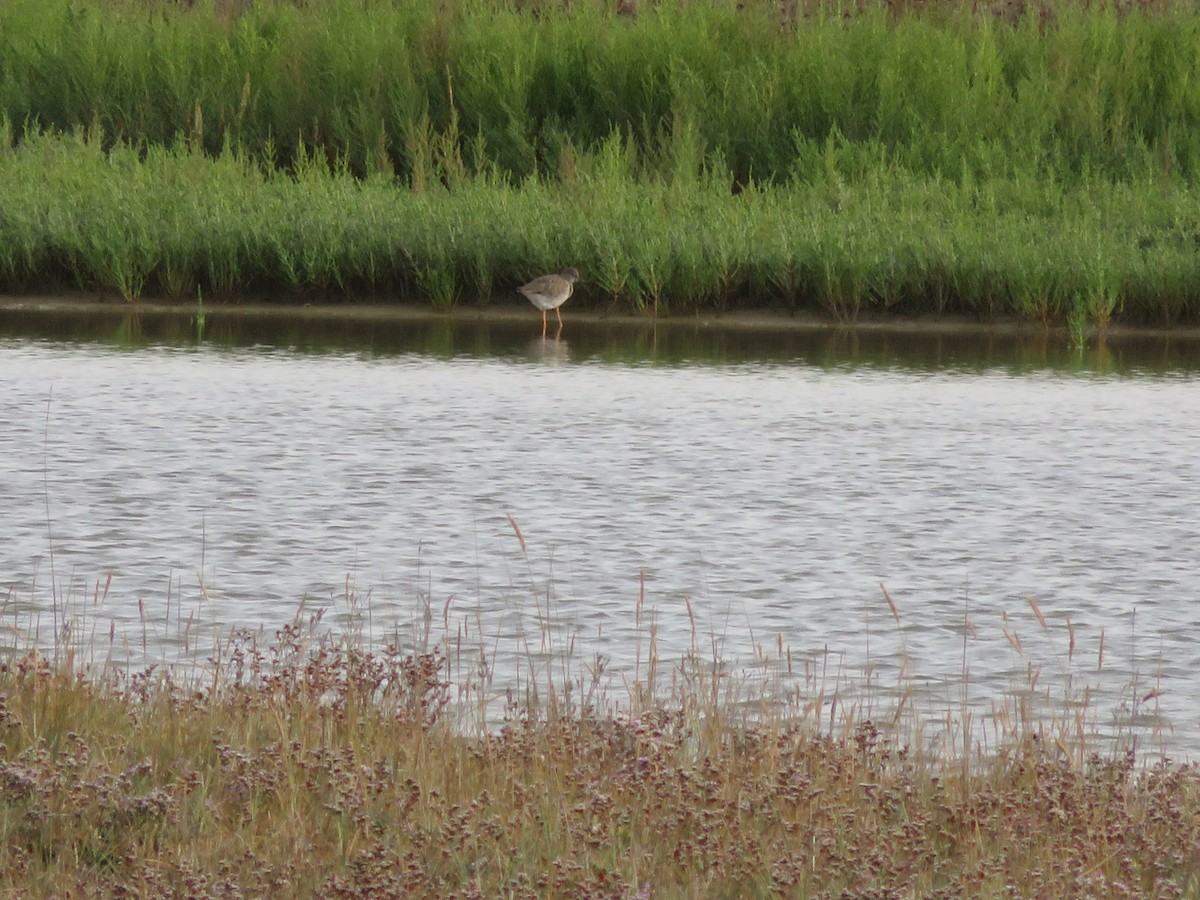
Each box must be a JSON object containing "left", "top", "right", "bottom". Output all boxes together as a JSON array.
[{"left": 0, "top": 304, "right": 1200, "bottom": 373}]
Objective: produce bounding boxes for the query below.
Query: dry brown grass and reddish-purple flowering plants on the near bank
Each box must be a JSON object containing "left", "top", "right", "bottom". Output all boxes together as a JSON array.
[{"left": 0, "top": 625, "right": 1200, "bottom": 898}]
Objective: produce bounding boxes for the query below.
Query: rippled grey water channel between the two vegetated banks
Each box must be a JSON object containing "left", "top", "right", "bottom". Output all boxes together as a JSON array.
[{"left": 0, "top": 313, "right": 1200, "bottom": 756}]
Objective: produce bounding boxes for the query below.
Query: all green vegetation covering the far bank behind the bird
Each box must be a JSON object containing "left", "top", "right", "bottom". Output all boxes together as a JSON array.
[{"left": 0, "top": 0, "right": 1200, "bottom": 335}]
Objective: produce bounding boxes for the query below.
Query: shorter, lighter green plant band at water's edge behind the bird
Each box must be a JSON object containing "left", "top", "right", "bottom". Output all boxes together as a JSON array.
[{"left": 0, "top": 122, "right": 1200, "bottom": 328}]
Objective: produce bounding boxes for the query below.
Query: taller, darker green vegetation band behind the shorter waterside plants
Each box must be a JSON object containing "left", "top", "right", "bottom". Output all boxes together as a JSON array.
[{"left": 7, "top": 0, "right": 1200, "bottom": 185}]
